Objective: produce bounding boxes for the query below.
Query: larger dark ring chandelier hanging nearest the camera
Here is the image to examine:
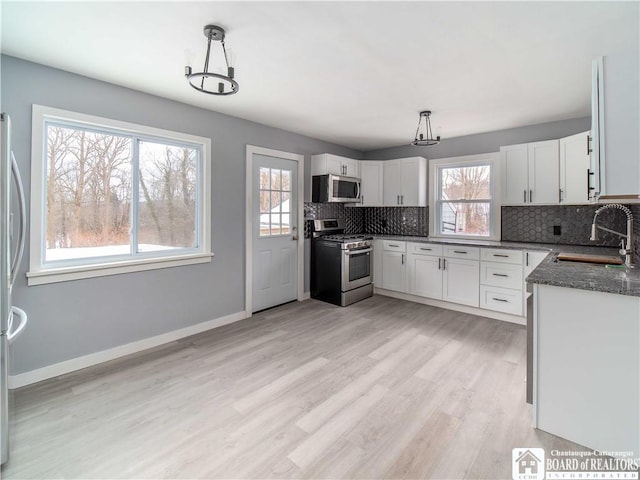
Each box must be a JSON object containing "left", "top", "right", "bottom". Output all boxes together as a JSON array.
[{"left": 184, "top": 25, "right": 240, "bottom": 95}]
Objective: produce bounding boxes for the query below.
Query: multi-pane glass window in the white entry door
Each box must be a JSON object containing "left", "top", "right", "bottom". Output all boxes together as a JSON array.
[{"left": 260, "top": 167, "right": 291, "bottom": 237}]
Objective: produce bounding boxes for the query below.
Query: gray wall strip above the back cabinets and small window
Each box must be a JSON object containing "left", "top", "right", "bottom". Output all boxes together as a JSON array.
[{"left": 363, "top": 117, "right": 591, "bottom": 160}]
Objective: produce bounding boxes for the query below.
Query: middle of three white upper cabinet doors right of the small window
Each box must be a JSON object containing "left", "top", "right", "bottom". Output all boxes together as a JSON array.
[{"left": 528, "top": 140, "right": 560, "bottom": 204}]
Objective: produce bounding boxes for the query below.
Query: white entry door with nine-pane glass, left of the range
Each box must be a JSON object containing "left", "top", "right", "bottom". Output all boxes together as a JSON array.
[{"left": 252, "top": 155, "right": 298, "bottom": 312}]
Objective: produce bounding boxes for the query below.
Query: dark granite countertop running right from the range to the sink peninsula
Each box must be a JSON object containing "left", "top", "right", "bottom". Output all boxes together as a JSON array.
[{"left": 373, "top": 235, "right": 640, "bottom": 297}]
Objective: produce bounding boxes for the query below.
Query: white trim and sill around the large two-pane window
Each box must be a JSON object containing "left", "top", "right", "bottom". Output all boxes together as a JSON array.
[{"left": 27, "top": 104, "right": 213, "bottom": 285}]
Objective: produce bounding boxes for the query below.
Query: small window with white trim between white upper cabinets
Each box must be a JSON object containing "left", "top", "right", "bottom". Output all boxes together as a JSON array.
[{"left": 430, "top": 154, "right": 500, "bottom": 240}]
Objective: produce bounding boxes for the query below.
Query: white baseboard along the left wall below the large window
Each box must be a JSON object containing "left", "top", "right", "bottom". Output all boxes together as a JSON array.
[{"left": 9, "top": 311, "right": 247, "bottom": 389}]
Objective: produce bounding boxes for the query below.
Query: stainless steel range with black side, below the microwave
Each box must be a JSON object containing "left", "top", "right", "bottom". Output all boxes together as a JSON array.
[{"left": 311, "top": 219, "right": 373, "bottom": 307}]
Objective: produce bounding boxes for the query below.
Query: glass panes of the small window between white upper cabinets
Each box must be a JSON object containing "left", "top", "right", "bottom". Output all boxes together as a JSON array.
[{"left": 438, "top": 165, "right": 491, "bottom": 236}]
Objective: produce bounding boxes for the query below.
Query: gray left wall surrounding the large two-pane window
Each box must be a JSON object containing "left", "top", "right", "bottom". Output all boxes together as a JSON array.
[{"left": 1, "top": 56, "right": 361, "bottom": 374}]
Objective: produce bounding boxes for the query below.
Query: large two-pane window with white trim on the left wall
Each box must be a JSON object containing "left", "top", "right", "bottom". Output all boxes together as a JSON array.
[{"left": 28, "top": 105, "right": 211, "bottom": 285}]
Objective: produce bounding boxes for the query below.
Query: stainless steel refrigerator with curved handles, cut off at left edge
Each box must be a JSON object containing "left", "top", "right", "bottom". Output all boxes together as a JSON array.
[{"left": 0, "top": 113, "right": 27, "bottom": 464}]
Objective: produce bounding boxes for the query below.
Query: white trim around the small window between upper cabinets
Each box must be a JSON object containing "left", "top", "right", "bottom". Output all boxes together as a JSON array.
[{"left": 429, "top": 152, "right": 502, "bottom": 240}]
